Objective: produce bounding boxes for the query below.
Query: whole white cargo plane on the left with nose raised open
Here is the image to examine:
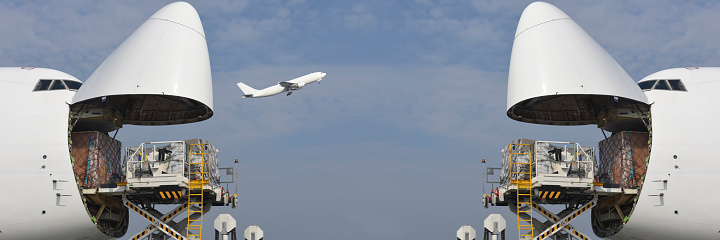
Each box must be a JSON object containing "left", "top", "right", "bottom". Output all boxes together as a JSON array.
[{"left": 0, "top": 2, "right": 213, "bottom": 240}]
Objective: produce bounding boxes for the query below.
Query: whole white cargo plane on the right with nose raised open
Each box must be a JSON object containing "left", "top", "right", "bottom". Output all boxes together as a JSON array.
[{"left": 496, "top": 2, "right": 720, "bottom": 240}]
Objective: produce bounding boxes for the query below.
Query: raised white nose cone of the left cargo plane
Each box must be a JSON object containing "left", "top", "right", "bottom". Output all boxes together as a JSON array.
[{"left": 72, "top": 2, "right": 213, "bottom": 125}]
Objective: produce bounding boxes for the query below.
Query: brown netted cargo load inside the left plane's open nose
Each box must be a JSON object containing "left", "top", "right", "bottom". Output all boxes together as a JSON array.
[{"left": 70, "top": 131, "right": 122, "bottom": 188}]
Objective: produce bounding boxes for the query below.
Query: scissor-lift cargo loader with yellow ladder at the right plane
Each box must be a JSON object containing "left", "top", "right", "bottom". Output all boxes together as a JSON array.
[{"left": 483, "top": 141, "right": 637, "bottom": 240}]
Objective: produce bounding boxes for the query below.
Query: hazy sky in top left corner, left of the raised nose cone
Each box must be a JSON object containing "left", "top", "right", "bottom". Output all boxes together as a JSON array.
[{"left": 0, "top": 1, "right": 162, "bottom": 79}]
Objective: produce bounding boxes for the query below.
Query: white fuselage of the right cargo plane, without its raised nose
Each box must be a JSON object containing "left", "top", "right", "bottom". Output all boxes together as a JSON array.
[{"left": 610, "top": 68, "right": 720, "bottom": 239}]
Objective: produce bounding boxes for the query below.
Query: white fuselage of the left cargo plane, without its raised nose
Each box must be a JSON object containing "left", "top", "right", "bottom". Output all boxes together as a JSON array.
[{"left": 0, "top": 67, "right": 109, "bottom": 239}]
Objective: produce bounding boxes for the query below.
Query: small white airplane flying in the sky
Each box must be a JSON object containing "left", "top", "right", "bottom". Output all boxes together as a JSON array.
[{"left": 237, "top": 72, "right": 325, "bottom": 98}]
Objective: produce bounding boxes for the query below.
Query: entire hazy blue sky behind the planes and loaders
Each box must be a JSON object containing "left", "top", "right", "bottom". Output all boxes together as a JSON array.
[{"left": 0, "top": 0, "right": 720, "bottom": 240}]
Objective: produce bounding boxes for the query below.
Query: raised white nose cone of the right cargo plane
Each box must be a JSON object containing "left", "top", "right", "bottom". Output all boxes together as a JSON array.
[{"left": 507, "top": 2, "right": 647, "bottom": 125}]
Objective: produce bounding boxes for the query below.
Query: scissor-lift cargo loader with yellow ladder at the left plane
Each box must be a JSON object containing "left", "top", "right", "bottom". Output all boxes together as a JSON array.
[{"left": 82, "top": 139, "right": 237, "bottom": 239}]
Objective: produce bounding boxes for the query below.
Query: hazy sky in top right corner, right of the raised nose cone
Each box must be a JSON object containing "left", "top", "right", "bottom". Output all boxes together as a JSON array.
[{"left": 558, "top": 1, "right": 720, "bottom": 80}]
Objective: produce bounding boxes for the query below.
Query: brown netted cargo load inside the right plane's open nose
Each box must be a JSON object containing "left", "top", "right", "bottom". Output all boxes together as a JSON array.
[{"left": 598, "top": 131, "right": 650, "bottom": 188}]
